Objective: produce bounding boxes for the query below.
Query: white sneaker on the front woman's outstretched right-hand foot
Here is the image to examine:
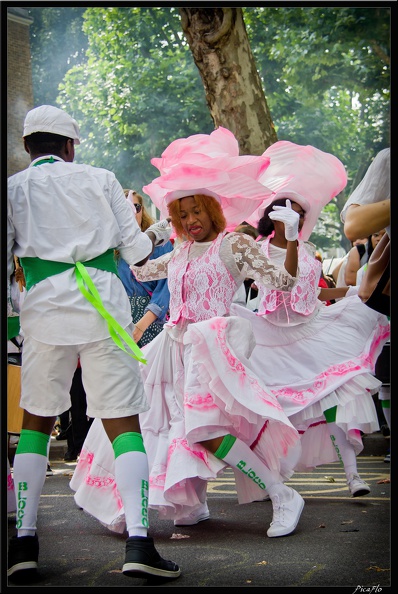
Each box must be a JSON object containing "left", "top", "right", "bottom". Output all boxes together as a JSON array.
[{"left": 267, "top": 485, "right": 304, "bottom": 538}]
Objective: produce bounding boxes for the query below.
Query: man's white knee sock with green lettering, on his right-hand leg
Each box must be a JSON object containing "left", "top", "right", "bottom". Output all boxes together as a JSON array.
[{"left": 115, "top": 451, "right": 149, "bottom": 536}]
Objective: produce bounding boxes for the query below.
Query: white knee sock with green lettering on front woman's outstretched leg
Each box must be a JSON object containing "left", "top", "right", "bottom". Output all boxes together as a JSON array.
[{"left": 222, "top": 439, "right": 287, "bottom": 498}]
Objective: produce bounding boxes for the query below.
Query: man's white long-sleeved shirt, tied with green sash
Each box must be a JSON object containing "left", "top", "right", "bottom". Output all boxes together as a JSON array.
[{"left": 7, "top": 157, "right": 152, "bottom": 345}]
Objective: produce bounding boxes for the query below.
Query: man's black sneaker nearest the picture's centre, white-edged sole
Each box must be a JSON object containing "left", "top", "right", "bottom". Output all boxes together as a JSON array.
[{"left": 122, "top": 536, "right": 181, "bottom": 579}]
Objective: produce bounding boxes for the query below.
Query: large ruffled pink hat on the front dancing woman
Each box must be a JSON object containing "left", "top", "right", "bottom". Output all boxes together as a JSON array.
[{"left": 143, "top": 127, "right": 272, "bottom": 228}]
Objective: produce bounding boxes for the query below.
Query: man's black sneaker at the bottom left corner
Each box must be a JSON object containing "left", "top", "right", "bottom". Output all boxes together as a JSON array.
[{"left": 7, "top": 534, "right": 39, "bottom": 578}]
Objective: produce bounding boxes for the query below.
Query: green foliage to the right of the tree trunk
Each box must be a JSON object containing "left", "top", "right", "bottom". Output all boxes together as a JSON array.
[{"left": 243, "top": 6, "right": 391, "bottom": 250}]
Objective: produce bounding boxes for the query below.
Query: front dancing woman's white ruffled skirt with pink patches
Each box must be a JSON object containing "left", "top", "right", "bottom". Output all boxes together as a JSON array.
[{"left": 70, "top": 316, "right": 301, "bottom": 532}]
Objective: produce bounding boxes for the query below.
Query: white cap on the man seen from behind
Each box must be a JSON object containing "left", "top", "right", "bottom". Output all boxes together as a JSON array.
[{"left": 22, "top": 105, "right": 80, "bottom": 144}]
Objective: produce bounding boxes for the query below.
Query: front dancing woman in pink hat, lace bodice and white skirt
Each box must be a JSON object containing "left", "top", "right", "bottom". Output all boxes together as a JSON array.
[{"left": 70, "top": 128, "right": 304, "bottom": 537}]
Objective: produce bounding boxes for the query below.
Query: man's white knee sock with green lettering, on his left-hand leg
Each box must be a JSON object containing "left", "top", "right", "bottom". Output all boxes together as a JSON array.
[{"left": 14, "top": 454, "right": 47, "bottom": 536}]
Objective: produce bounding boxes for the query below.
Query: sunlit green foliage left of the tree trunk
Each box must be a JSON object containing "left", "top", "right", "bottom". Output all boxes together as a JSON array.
[{"left": 58, "top": 7, "right": 214, "bottom": 191}]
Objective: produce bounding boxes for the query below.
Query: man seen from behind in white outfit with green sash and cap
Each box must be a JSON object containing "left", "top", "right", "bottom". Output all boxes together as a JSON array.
[{"left": 7, "top": 105, "right": 180, "bottom": 580}]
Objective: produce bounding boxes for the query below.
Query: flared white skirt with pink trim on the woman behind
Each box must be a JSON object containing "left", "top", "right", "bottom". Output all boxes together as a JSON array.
[{"left": 231, "top": 295, "right": 390, "bottom": 470}]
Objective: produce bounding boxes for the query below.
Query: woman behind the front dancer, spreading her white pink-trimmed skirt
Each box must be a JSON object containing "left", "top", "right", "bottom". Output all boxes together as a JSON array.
[{"left": 231, "top": 197, "right": 389, "bottom": 497}]
